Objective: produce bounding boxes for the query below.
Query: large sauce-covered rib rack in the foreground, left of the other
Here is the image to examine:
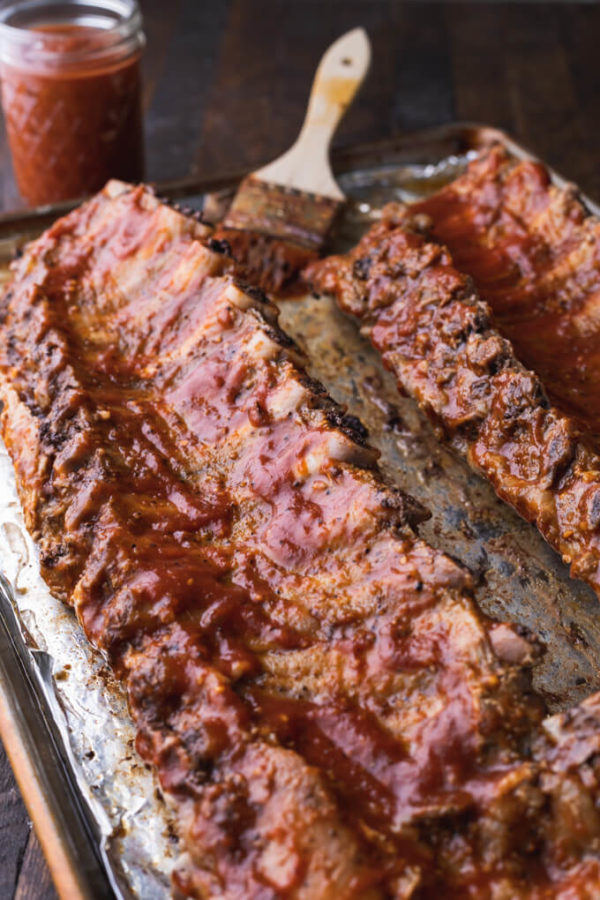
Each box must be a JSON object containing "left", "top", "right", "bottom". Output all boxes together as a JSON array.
[{"left": 0, "top": 183, "right": 600, "bottom": 900}]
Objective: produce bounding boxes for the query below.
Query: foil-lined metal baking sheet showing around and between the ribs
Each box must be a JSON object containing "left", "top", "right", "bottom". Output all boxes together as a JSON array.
[{"left": 0, "top": 125, "right": 600, "bottom": 900}]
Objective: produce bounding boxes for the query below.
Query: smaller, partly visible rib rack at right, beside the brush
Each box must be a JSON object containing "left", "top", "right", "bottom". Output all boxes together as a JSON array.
[{"left": 308, "top": 148, "right": 600, "bottom": 593}]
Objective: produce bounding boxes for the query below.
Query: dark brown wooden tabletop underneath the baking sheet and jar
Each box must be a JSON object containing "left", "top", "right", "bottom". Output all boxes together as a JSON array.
[{"left": 0, "top": 0, "right": 600, "bottom": 900}]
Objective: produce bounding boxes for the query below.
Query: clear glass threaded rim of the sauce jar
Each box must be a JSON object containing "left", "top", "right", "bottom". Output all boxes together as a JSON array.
[{"left": 0, "top": 0, "right": 144, "bottom": 67}]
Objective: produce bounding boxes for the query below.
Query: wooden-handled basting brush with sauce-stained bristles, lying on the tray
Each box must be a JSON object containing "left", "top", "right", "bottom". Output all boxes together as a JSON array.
[{"left": 214, "top": 28, "right": 371, "bottom": 293}]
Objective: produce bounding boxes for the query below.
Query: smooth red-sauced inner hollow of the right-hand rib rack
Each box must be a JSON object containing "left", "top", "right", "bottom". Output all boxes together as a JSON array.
[{"left": 414, "top": 146, "right": 600, "bottom": 436}]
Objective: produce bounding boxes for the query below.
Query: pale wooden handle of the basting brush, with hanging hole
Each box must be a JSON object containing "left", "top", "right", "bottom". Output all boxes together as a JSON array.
[{"left": 254, "top": 28, "right": 371, "bottom": 200}]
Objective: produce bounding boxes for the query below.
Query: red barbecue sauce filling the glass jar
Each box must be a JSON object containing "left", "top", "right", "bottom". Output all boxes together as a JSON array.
[{"left": 1, "top": 25, "right": 144, "bottom": 205}]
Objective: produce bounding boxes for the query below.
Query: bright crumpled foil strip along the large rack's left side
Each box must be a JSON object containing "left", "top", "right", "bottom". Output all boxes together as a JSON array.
[{"left": 0, "top": 445, "right": 178, "bottom": 900}]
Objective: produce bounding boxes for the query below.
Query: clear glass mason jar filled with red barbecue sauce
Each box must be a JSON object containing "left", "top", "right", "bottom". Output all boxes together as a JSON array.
[{"left": 0, "top": 0, "right": 145, "bottom": 205}]
